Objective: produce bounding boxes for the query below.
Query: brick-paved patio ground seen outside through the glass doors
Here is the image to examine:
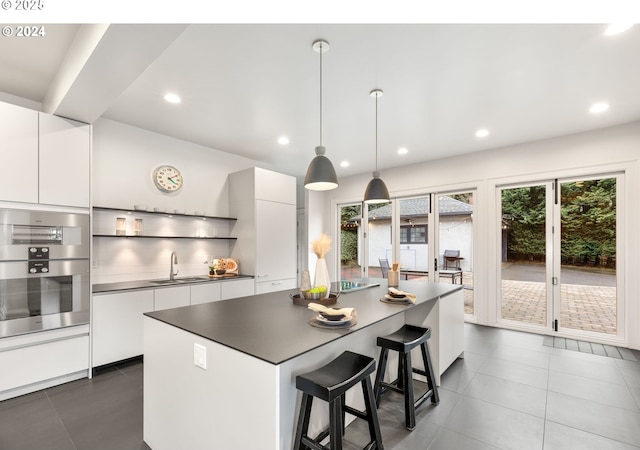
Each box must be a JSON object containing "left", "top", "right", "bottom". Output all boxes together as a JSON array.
[{"left": 342, "top": 265, "right": 617, "bottom": 334}]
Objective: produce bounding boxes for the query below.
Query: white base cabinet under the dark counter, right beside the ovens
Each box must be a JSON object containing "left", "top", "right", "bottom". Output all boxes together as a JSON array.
[{"left": 92, "top": 289, "right": 154, "bottom": 367}]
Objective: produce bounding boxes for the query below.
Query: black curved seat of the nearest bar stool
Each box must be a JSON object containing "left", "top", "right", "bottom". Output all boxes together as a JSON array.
[{"left": 296, "top": 352, "right": 376, "bottom": 402}]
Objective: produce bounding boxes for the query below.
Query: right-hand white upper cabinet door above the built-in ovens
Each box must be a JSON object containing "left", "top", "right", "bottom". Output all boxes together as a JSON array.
[{"left": 38, "top": 113, "right": 91, "bottom": 207}]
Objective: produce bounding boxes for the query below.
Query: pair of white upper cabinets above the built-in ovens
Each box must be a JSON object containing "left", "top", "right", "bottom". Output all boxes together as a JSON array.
[{"left": 0, "top": 102, "right": 91, "bottom": 207}]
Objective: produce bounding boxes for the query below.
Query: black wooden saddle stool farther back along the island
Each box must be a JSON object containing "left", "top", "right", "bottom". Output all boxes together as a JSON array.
[{"left": 374, "top": 325, "right": 440, "bottom": 430}]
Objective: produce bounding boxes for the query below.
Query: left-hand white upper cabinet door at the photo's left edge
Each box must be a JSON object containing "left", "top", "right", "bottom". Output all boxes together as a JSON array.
[{"left": 0, "top": 102, "right": 38, "bottom": 203}]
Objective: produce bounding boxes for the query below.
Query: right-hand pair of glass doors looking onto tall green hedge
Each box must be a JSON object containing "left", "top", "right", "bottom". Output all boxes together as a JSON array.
[{"left": 498, "top": 175, "right": 623, "bottom": 340}]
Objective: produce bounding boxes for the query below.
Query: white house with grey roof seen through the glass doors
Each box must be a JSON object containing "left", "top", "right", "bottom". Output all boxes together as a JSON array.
[{"left": 358, "top": 195, "right": 473, "bottom": 271}]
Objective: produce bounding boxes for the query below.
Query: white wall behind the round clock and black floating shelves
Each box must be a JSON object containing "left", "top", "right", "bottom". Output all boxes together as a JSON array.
[{"left": 92, "top": 119, "right": 270, "bottom": 284}]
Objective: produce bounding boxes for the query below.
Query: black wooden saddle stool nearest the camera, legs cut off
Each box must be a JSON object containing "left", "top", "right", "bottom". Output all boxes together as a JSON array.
[{"left": 293, "top": 351, "right": 383, "bottom": 450}]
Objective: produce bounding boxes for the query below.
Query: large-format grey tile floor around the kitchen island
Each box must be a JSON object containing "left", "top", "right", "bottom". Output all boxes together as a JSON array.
[{"left": 0, "top": 324, "right": 640, "bottom": 450}]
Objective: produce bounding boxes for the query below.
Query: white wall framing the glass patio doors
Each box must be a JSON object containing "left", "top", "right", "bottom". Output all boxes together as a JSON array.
[{"left": 322, "top": 122, "right": 640, "bottom": 348}]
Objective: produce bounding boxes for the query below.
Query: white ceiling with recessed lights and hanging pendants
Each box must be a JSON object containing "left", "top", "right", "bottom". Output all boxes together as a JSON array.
[{"left": 0, "top": 24, "right": 640, "bottom": 177}]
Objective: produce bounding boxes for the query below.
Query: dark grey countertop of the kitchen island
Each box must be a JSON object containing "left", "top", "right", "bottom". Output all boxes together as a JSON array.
[{"left": 145, "top": 279, "right": 462, "bottom": 365}]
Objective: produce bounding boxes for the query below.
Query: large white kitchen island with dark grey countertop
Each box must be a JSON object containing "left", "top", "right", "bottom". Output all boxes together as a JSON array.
[{"left": 144, "top": 280, "right": 464, "bottom": 450}]
